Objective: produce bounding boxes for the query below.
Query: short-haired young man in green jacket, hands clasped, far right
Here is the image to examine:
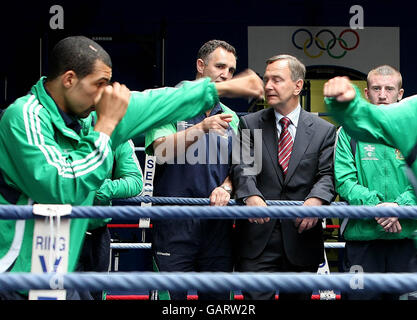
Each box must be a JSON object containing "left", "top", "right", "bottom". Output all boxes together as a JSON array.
[{"left": 334, "top": 65, "right": 417, "bottom": 300}]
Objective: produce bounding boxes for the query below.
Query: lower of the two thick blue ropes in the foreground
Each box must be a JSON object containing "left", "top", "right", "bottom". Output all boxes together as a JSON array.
[{"left": 0, "top": 271, "right": 417, "bottom": 293}]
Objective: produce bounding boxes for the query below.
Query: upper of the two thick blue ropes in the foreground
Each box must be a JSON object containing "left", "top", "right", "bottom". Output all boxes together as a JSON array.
[{"left": 0, "top": 205, "right": 417, "bottom": 220}]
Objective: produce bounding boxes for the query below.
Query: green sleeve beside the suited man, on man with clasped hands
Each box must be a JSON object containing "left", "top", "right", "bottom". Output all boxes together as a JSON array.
[{"left": 334, "top": 128, "right": 382, "bottom": 205}]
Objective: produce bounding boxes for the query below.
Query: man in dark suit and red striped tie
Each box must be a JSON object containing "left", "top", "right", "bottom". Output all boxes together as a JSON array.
[{"left": 232, "top": 55, "right": 336, "bottom": 300}]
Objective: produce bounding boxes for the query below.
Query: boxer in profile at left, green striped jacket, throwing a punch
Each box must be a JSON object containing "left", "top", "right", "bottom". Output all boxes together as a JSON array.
[{"left": 0, "top": 37, "right": 263, "bottom": 288}]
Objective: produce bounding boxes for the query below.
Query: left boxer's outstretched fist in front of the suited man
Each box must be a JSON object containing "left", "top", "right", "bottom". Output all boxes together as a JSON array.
[{"left": 215, "top": 69, "right": 264, "bottom": 99}]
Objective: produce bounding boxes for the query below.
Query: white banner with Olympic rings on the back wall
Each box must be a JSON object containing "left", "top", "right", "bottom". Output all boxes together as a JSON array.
[{"left": 248, "top": 26, "right": 400, "bottom": 75}]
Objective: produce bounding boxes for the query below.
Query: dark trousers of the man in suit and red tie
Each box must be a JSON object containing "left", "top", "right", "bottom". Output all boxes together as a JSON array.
[{"left": 236, "top": 221, "right": 318, "bottom": 300}]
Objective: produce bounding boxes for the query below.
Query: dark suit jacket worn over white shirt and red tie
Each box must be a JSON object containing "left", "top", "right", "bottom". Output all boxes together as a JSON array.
[{"left": 232, "top": 108, "right": 336, "bottom": 266}]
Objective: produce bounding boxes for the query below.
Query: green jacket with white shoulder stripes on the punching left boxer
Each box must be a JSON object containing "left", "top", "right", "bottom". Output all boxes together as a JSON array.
[{"left": 0, "top": 78, "right": 218, "bottom": 272}]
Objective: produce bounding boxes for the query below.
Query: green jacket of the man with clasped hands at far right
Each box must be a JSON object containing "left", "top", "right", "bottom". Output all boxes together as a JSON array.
[{"left": 334, "top": 128, "right": 417, "bottom": 240}]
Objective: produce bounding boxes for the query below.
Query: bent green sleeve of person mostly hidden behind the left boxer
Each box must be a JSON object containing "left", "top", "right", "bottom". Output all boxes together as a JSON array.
[{"left": 95, "top": 140, "right": 143, "bottom": 205}]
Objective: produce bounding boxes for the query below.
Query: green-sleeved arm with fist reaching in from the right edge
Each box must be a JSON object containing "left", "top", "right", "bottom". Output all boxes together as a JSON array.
[{"left": 323, "top": 77, "right": 417, "bottom": 179}]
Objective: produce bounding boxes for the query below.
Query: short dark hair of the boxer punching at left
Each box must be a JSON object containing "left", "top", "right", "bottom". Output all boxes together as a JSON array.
[{"left": 47, "top": 36, "right": 112, "bottom": 80}]
